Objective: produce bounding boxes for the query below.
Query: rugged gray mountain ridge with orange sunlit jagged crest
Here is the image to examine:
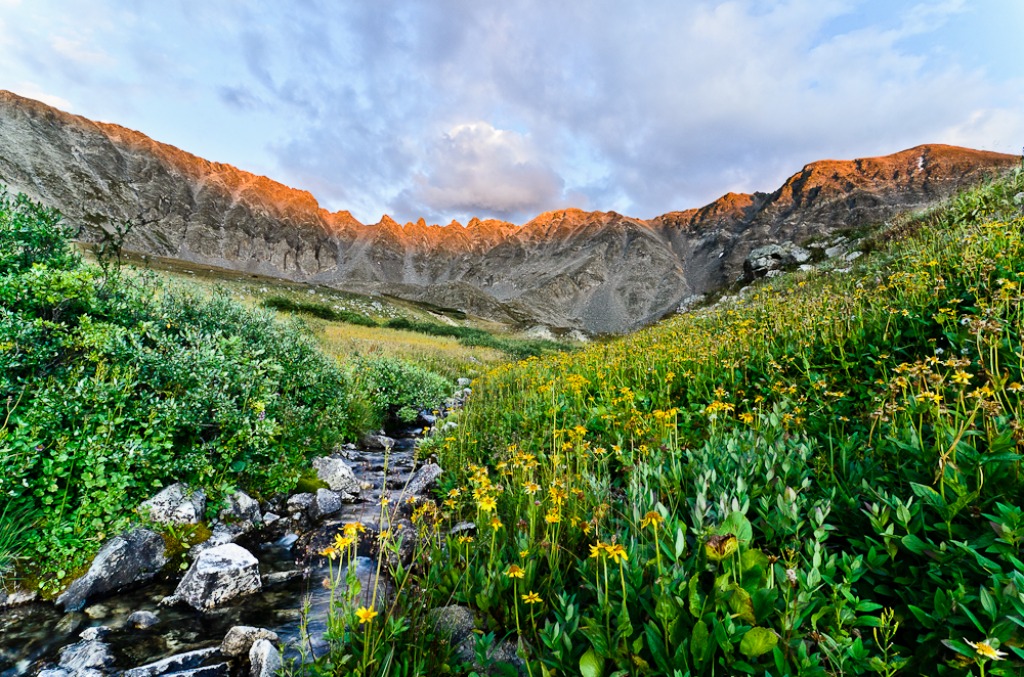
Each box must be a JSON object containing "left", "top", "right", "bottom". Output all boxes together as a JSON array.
[{"left": 0, "top": 92, "right": 1019, "bottom": 333}]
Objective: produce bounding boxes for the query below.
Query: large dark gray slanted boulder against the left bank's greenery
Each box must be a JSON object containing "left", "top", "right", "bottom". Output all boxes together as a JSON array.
[{"left": 56, "top": 528, "right": 167, "bottom": 610}]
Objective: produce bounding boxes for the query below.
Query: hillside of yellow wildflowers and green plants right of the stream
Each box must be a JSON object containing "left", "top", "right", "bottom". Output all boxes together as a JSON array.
[{"left": 319, "top": 172, "right": 1024, "bottom": 677}]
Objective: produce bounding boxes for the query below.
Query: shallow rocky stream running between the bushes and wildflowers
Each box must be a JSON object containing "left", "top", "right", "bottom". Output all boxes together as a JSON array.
[{"left": 0, "top": 430, "right": 419, "bottom": 677}]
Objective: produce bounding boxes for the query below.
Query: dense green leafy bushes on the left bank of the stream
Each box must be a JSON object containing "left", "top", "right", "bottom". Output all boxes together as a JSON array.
[{"left": 0, "top": 188, "right": 360, "bottom": 589}]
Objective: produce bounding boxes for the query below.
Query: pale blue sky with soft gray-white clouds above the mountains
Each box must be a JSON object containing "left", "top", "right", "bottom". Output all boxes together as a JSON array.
[{"left": 0, "top": 0, "right": 1024, "bottom": 223}]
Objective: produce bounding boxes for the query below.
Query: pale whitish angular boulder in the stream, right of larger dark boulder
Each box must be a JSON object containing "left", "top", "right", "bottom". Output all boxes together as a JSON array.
[{"left": 164, "top": 543, "right": 262, "bottom": 610}]
